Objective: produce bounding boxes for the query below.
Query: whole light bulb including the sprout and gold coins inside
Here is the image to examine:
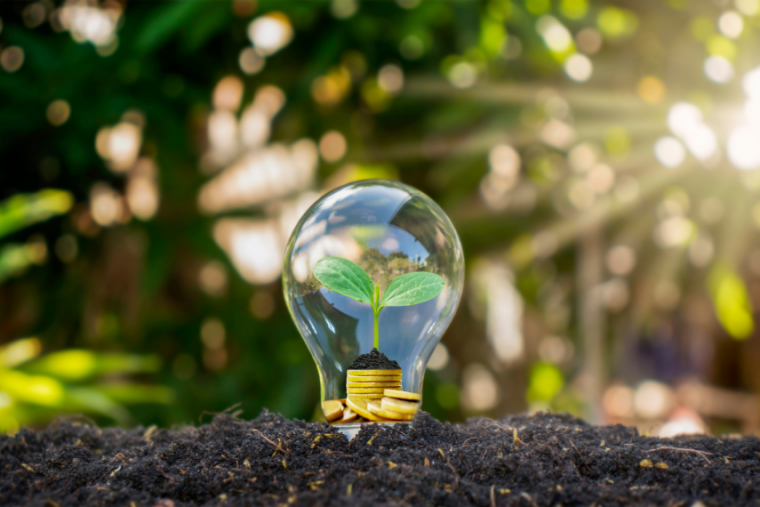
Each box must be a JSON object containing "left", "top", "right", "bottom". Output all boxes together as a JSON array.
[{"left": 283, "top": 180, "right": 464, "bottom": 423}]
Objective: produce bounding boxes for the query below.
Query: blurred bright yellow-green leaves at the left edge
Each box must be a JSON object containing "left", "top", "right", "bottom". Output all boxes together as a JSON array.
[{"left": 0, "top": 189, "right": 174, "bottom": 432}]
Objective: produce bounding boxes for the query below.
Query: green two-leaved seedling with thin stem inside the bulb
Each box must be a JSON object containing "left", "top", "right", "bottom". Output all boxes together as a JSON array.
[{"left": 314, "top": 257, "right": 445, "bottom": 350}]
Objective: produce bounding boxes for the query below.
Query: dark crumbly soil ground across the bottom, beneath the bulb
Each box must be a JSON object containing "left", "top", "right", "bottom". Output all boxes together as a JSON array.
[{"left": 0, "top": 412, "right": 760, "bottom": 507}]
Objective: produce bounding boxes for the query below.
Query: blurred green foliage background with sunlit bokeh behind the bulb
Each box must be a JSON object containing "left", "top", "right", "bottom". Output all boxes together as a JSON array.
[{"left": 0, "top": 0, "right": 760, "bottom": 435}]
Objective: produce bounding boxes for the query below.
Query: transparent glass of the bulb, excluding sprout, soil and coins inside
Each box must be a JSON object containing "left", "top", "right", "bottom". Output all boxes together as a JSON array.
[{"left": 283, "top": 180, "right": 464, "bottom": 420}]
